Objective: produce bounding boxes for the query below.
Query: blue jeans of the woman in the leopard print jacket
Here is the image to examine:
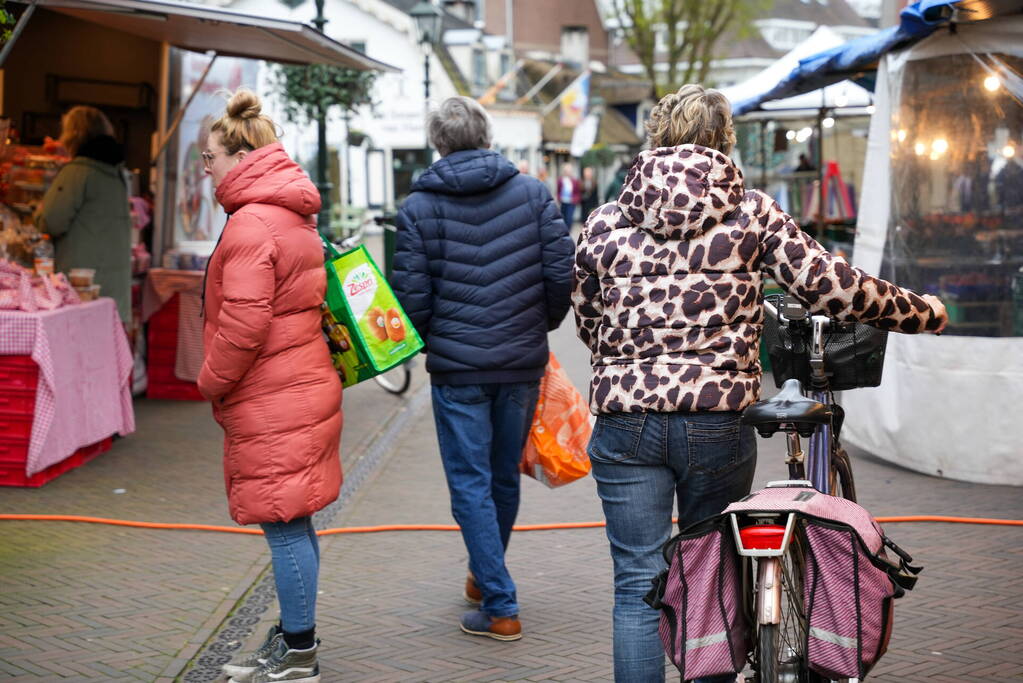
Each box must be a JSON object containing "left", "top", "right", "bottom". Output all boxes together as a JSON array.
[{"left": 588, "top": 412, "right": 757, "bottom": 683}]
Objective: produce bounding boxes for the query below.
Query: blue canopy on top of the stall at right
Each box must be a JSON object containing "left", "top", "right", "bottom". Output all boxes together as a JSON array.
[{"left": 731, "top": 0, "right": 969, "bottom": 116}]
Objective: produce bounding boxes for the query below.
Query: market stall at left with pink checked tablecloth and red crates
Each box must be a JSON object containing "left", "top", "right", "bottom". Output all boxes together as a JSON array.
[{"left": 0, "top": 0, "right": 391, "bottom": 486}]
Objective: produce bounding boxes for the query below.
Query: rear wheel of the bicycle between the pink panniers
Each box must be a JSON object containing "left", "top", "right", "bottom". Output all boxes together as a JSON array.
[{"left": 756, "top": 534, "right": 825, "bottom": 683}]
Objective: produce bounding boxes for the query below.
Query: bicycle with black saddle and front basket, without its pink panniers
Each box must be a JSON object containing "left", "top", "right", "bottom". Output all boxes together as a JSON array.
[{"left": 730, "top": 295, "right": 887, "bottom": 683}]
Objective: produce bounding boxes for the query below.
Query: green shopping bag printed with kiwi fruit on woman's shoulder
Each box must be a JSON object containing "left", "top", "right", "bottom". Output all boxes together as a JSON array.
[{"left": 320, "top": 235, "right": 422, "bottom": 386}]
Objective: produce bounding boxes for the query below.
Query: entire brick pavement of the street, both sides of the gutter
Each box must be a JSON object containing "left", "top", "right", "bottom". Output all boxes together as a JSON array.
[{"left": 0, "top": 316, "right": 1023, "bottom": 682}]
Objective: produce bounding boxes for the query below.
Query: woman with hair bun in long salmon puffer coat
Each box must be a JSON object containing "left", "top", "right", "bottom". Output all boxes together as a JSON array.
[{"left": 198, "top": 90, "right": 342, "bottom": 683}]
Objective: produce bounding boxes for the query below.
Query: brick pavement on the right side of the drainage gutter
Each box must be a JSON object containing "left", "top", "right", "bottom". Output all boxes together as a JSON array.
[{"left": 217, "top": 326, "right": 1023, "bottom": 683}]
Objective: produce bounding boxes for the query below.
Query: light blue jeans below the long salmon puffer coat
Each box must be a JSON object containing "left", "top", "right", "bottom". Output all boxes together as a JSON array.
[{"left": 260, "top": 517, "right": 319, "bottom": 633}]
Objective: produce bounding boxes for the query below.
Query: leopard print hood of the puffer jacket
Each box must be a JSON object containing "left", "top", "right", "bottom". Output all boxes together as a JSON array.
[{"left": 617, "top": 144, "right": 745, "bottom": 239}]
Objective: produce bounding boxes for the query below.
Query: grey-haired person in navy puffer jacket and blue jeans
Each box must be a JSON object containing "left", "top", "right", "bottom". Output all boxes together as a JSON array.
[{"left": 393, "top": 97, "right": 575, "bottom": 640}]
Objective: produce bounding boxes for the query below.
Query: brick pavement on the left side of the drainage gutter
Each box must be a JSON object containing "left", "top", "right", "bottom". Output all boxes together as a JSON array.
[{"left": 0, "top": 365, "right": 425, "bottom": 681}]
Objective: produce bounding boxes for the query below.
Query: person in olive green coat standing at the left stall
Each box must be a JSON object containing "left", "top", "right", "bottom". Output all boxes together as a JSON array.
[{"left": 35, "top": 106, "right": 132, "bottom": 324}]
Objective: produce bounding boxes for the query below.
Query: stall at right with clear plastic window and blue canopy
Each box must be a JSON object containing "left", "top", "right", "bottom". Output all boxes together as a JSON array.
[{"left": 742, "top": 0, "right": 1023, "bottom": 486}]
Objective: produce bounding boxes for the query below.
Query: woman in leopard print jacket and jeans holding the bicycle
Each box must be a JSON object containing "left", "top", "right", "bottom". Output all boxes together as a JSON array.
[{"left": 573, "top": 85, "right": 947, "bottom": 683}]
